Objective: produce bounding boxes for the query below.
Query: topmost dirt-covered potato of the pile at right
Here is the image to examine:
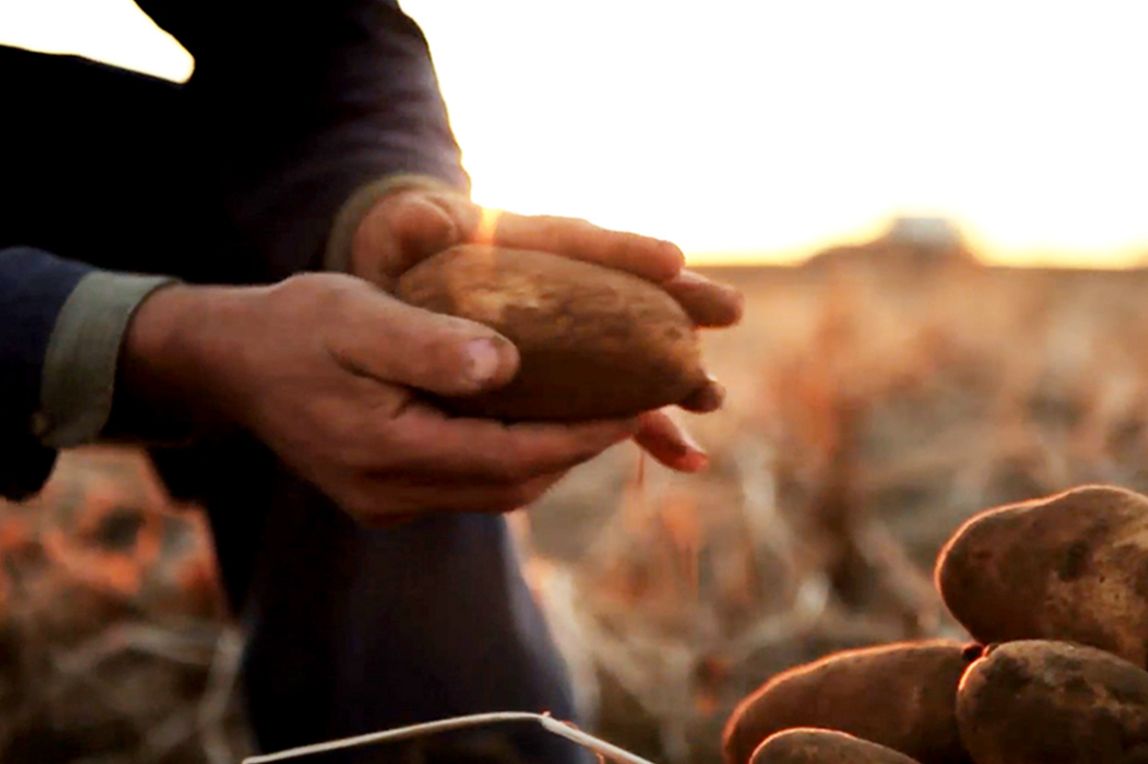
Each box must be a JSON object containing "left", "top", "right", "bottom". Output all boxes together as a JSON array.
[{"left": 937, "top": 486, "right": 1148, "bottom": 666}]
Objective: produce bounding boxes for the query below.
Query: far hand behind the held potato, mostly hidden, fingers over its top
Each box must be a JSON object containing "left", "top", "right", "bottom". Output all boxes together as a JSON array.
[{"left": 350, "top": 186, "right": 743, "bottom": 471}]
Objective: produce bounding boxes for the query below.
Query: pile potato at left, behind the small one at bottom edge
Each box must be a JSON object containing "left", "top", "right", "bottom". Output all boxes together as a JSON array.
[{"left": 724, "top": 641, "right": 980, "bottom": 764}]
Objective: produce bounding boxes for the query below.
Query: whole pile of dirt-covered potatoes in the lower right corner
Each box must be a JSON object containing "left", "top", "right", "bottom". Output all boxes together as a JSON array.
[{"left": 724, "top": 486, "right": 1148, "bottom": 764}]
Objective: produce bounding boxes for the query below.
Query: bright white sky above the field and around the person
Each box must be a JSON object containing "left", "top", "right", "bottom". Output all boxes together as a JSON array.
[{"left": 0, "top": 0, "right": 1148, "bottom": 265}]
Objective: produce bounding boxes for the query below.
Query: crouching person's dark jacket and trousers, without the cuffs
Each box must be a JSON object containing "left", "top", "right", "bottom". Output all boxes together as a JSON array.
[{"left": 0, "top": 0, "right": 583, "bottom": 763}]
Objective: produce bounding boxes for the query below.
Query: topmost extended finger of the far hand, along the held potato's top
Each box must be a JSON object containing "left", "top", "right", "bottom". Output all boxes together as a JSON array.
[{"left": 475, "top": 212, "right": 685, "bottom": 283}]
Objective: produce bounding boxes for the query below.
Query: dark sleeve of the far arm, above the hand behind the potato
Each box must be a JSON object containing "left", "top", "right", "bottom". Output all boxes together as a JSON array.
[{"left": 138, "top": 0, "right": 468, "bottom": 279}]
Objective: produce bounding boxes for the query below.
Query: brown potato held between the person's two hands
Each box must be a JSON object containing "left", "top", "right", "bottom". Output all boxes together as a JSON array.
[{"left": 395, "top": 244, "right": 705, "bottom": 421}]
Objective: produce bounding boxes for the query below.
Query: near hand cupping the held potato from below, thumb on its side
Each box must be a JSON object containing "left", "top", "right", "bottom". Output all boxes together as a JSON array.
[{"left": 121, "top": 274, "right": 638, "bottom": 525}]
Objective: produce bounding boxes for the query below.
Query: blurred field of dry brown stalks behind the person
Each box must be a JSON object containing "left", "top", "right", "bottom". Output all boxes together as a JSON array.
[{"left": 0, "top": 227, "right": 1148, "bottom": 763}]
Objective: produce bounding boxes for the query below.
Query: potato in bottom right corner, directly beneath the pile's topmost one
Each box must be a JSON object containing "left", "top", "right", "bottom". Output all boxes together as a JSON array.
[{"left": 956, "top": 640, "right": 1148, "bottom": 764}]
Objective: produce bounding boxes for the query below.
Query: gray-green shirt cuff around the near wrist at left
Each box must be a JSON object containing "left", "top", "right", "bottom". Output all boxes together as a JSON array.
[{"left": 33, "top": 271, "right": 176, "bottom": 449}]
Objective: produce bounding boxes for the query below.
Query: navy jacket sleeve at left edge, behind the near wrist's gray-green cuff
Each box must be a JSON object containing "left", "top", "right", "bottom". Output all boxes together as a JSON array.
[{"left": 0, "top": 247, "right": 91, "bottom": 499}]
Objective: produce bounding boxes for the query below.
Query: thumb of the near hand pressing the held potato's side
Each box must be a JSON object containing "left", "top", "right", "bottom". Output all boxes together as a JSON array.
[{"left": 332, "top": 283, "right": 519, "bottom": 396}]
